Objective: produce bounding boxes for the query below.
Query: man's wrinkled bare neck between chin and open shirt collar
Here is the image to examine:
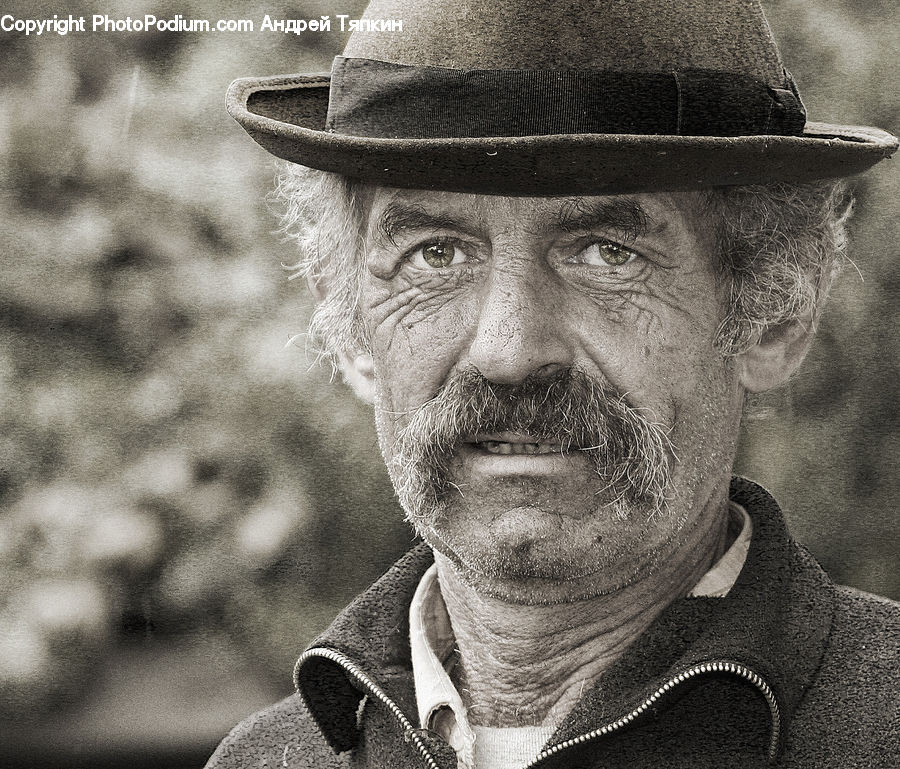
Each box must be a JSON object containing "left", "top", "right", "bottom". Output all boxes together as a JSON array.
[{"left": 435, "top": 484, "right": 728, "bottom": 727}]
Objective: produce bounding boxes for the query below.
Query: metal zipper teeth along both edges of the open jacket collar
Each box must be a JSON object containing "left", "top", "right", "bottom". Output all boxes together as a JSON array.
[{"left": 294, "top": 648, "right": 781, "bottom": 769}]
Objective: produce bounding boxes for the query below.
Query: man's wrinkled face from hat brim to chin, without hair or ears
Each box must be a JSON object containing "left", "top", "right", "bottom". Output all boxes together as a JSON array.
[{"left": 362, "top": 189, "right": 743, "bottom": 601}]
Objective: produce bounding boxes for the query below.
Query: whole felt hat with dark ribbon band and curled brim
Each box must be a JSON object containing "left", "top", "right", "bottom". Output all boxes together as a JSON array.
[{"left": 227, "top": 0, "right": 897, "bottom": 195}]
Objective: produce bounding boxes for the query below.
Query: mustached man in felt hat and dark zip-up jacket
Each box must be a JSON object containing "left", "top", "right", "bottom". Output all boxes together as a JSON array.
[{"left": 210, "top": 0, "right": 900, "bottom": 769}]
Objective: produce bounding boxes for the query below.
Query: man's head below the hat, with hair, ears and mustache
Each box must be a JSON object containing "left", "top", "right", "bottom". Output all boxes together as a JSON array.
[{"left": 281, "top": 178, "right": 846, "bottom": 600}]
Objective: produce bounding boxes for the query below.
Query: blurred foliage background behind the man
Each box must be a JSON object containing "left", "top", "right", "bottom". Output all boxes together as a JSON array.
[{"left": 0, "top": 0, "right": 900, "bottom": 767}]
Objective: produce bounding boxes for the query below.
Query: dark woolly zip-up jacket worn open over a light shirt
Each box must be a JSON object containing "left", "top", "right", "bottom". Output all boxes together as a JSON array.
[{"left": 208, "top": 479, "right": 900, "bottom": 769}]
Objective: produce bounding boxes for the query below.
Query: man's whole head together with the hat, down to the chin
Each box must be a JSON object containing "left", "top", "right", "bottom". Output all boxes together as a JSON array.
[{"left": 229, "top": 0, "right": 896, "bottom": 601}]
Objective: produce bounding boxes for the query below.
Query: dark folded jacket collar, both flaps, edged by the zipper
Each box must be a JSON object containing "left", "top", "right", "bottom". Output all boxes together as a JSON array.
[{"left": 295, "top": 478, "right": 833, "bottom": 751}]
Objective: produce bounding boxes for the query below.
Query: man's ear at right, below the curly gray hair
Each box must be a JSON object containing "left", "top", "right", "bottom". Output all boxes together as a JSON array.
[{"left": 737, "top": 314, "right": 815, "bottom": 393}]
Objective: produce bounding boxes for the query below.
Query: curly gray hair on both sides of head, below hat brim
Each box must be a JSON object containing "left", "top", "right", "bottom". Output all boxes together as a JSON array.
[{"left": 274, "top": 163, "right": 852, "bottom": 361}]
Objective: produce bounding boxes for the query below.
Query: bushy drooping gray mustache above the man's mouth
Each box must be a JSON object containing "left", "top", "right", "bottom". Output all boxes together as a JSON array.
[{"left": 390, "top": 368, "right": 674, "bottom": 517}]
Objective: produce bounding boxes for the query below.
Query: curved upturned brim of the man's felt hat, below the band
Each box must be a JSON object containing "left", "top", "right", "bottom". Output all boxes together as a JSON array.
[{"left": 226, "top": 74, "right": 898, "bottom": 195}]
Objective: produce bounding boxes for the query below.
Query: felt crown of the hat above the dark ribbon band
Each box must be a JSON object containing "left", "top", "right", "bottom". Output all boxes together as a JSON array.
[{"left": 344, "top": 0, "right": 785, "bottom": 85}]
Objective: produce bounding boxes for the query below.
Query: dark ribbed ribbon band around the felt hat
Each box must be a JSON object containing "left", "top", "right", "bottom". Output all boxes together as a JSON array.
[{"left": 326, "top": 56, "right": 806, "bottom": 139}]
